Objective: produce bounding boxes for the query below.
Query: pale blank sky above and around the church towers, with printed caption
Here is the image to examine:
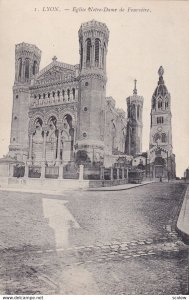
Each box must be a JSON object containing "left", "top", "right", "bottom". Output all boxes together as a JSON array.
[{"left": 0, "top": 0, "right": 189, "bottom": 176}]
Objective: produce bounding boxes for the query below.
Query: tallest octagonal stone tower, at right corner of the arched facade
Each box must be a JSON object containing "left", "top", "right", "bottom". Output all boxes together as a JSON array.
[{"left": 76, "top": 20, "right": 109, "bottom": 163}]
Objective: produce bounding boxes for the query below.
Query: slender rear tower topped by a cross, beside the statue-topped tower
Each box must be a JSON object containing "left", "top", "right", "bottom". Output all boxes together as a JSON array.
[{"left": 125, "top": 79, "right": 144, "bottom": 156}]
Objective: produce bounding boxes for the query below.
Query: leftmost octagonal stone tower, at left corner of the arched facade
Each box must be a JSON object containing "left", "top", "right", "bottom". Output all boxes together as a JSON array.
[{"left": 9, "top": 43, "right": 41, "bottom": 161}]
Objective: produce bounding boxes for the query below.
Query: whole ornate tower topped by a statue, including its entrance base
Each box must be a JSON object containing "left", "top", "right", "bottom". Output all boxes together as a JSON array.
[{"left": 149, "top": 66, "right": 175, "bottom": 179}]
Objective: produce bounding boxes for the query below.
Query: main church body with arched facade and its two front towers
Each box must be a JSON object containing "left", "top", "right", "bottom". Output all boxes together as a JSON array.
[{"left": 9, "top": 20, "right": 127, "bottom": 171}]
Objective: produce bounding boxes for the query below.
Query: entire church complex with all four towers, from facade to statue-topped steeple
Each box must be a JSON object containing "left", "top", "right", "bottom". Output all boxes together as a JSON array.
[{"left": 4, "top": 20, "right": 175, "bottom": 179}]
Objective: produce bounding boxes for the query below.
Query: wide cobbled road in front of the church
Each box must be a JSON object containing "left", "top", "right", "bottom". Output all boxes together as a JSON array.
[{"left": 0, "top": 183, "right": 188, "bottom": 294}]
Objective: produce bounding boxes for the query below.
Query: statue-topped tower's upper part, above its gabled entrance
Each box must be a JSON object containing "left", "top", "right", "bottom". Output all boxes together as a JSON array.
[{"left": 150, "top": 66, "right": 172, "bottom": 155}]
